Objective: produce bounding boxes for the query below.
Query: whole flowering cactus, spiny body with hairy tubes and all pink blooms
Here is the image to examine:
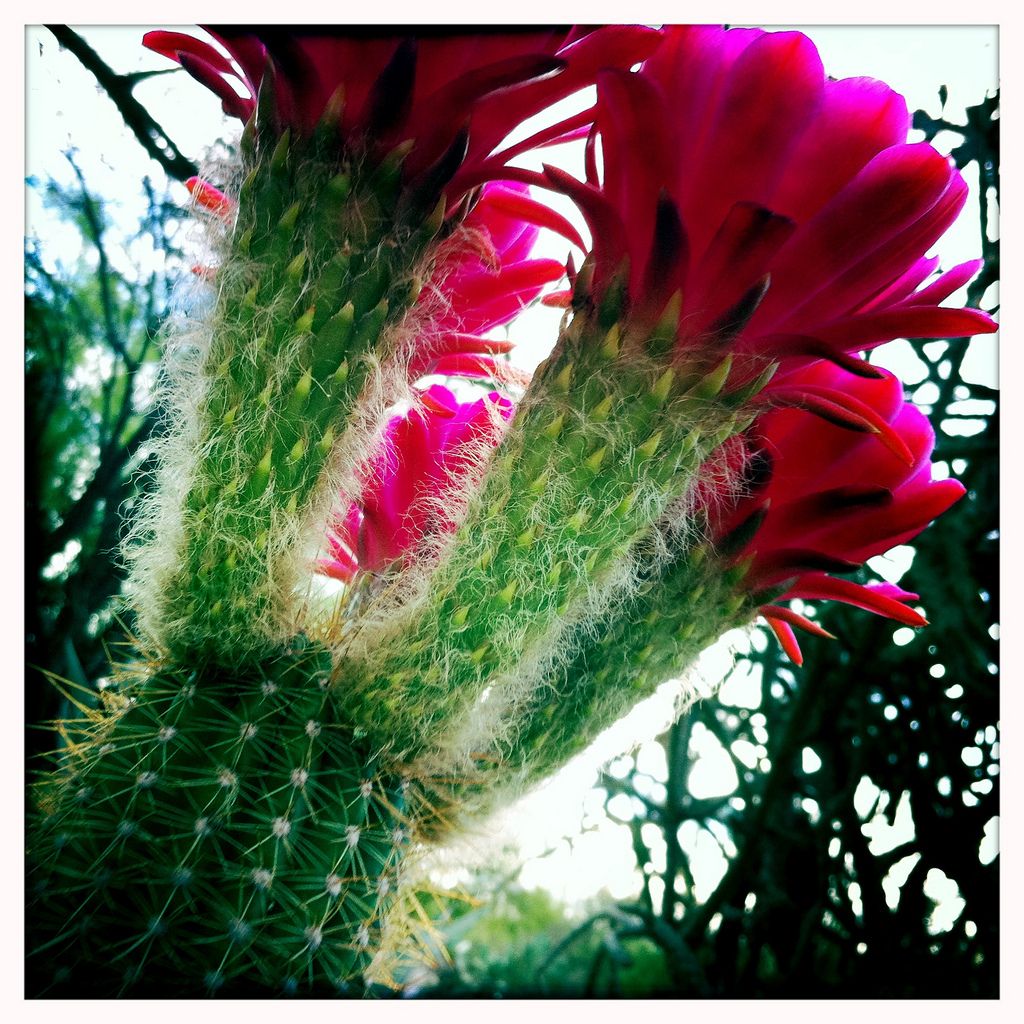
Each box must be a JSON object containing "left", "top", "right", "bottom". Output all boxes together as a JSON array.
[{"left": 29, "top": 27, "right": 993, "bottom": 995}]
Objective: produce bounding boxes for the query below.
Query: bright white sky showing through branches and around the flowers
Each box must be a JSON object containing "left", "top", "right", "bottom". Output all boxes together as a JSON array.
[{"left": 26, "top": 25, "right": 997, "bottom": 902}]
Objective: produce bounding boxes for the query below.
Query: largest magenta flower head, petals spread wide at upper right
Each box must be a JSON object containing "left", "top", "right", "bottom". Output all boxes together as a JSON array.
[{"left": 532, "top": 26, "right": 995, "bottom": 373}]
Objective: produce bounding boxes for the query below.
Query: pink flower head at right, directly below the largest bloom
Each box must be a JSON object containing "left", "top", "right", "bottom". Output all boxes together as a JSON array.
[{"left": 703, "top": 360, "right": 964, "bottom": 664}]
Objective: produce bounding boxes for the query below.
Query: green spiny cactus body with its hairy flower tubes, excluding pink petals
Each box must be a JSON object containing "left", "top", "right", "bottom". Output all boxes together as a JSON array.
[{"left": 30, "top": 59, "right": 770, "bottom": 994}]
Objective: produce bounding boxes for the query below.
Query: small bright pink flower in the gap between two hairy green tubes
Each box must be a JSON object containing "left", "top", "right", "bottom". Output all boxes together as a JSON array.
[{"left": 317, "top": 384, "right": 512, "bottom": 582}]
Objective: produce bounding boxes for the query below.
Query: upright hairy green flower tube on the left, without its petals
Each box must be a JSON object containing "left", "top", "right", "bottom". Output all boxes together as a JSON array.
[{"left": 155, "top": 119, "right": 440, "bottom": 664}]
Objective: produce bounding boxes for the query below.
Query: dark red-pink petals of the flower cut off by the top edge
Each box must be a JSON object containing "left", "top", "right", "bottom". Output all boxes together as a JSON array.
[{"left": 143, "top": 26, "right": 659, "bottom": 202}]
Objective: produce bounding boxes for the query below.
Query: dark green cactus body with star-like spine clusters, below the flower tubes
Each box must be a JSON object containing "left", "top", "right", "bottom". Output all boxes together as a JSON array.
[{"left": 28, "top": 645, "right": 410, "bottom": 995}]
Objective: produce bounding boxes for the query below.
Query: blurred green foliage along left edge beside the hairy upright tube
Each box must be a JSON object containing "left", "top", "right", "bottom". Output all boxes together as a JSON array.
[{"left": 25, "top": 156, "right": 176, "bottom": 751}]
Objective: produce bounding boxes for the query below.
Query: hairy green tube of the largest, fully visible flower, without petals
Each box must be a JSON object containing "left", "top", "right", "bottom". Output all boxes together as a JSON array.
[{"left": 345, "top": 307, "right": 765, "bottom": 756}]
